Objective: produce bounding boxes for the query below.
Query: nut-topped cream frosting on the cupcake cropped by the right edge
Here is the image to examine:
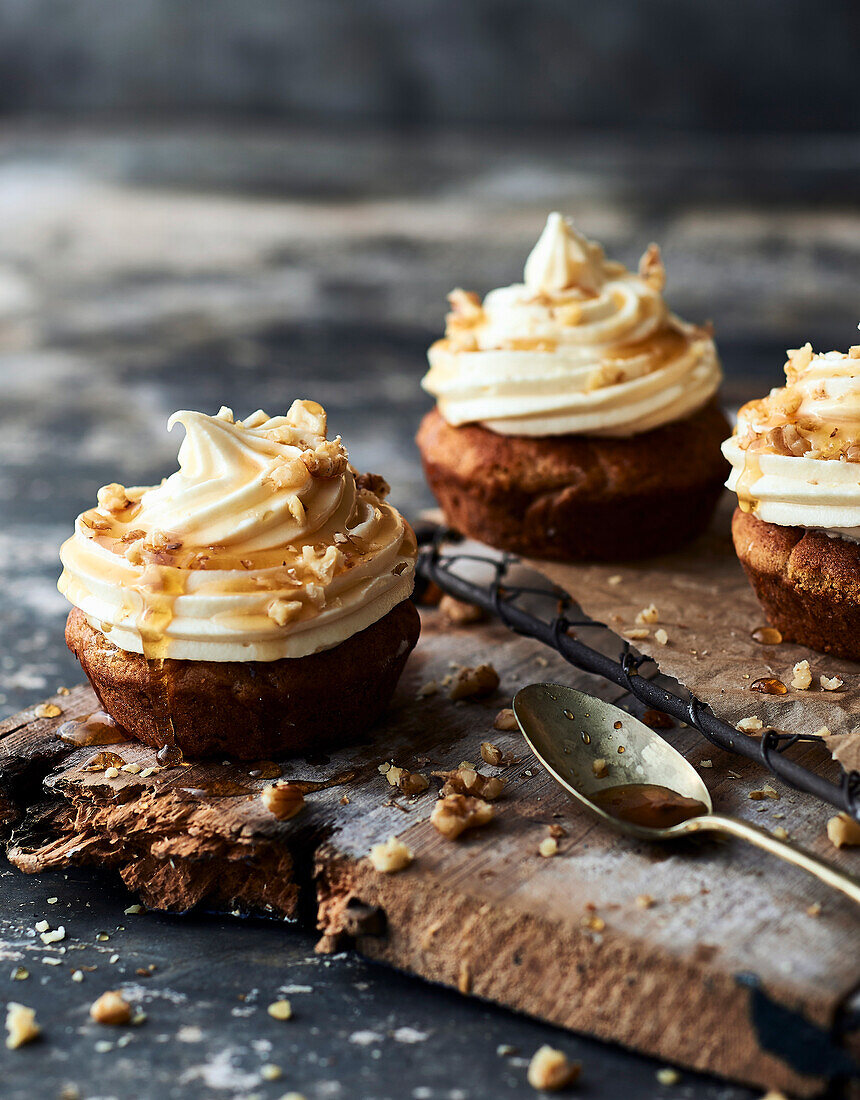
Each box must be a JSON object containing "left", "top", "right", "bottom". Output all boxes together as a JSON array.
[{"left": 723, "top": 343, "right": 860, "bottom": 541}]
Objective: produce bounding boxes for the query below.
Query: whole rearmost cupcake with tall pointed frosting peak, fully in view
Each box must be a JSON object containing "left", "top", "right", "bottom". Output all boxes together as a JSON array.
[{"left": 418, "top": 213, "right": 728, "bottom": 560}]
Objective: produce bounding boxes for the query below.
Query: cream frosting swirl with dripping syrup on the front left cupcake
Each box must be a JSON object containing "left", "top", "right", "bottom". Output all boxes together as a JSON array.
[{"left": 58, "top": 400, "right": 416, "bottom": 661}]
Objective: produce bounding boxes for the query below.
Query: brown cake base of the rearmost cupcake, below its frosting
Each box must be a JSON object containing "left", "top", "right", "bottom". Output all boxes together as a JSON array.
[{"left": 417, "top": 400, "right": 730, "bottom": 561}]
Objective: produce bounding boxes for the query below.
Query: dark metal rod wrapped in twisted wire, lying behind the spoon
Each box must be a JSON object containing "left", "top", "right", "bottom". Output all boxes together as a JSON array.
[{"left": 417, "top": 524, "right": 860, "bottom": 822}]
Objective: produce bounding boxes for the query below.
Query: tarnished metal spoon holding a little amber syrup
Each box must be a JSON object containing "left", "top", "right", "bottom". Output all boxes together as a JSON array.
[{"left": 514, "top": 684, "right": 860, "bottom": 903}]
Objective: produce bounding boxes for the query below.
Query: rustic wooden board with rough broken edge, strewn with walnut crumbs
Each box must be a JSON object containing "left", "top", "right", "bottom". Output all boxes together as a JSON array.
[{"left": 0, "top": 611, "right": 860, "bottom": 1096}]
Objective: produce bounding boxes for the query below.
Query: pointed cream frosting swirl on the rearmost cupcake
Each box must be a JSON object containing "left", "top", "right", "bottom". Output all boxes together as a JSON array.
[{"left": 422, "top": 213, "right": 721, "bottom": 436}]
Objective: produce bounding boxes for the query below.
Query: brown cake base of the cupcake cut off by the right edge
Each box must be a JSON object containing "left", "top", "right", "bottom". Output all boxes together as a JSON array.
[{"left": 731, "top": 508, "right": 860, "bottom": 661}]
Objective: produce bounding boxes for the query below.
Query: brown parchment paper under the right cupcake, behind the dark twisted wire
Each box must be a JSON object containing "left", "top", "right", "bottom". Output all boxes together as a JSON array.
[{"left": 529, "top": 494, "right": 860, "bottom": 770}]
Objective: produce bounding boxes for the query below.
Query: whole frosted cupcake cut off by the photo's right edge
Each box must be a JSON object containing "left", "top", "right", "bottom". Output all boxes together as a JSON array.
[{"left": 723, "top": 343, "right": 860, "bottom": 660}]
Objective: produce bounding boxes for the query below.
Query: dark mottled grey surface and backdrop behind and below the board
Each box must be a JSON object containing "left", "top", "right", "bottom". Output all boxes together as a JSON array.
[{"left": 0, "top": 0, "right": 860, "bottom": 1100}]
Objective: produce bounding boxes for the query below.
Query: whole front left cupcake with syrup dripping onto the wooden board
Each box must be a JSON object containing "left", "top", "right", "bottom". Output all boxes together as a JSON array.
[{"left": 58, "top": 400, "right": 419, "bottom": 761}]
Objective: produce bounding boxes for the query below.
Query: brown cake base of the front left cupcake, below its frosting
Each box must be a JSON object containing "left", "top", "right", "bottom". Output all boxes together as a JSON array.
[{"left": 66, "top": 600, "right": 420, "bottom": 760}]
